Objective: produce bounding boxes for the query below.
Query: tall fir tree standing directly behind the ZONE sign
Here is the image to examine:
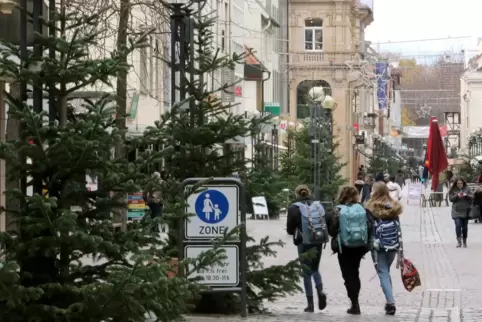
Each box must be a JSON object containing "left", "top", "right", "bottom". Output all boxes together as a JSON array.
[{"left": 153, "top": 3, "right": 301, "bottom": 313}]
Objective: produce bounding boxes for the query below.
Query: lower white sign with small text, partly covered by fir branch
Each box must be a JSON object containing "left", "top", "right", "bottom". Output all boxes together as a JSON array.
[{"left": 184, "top": 245, "right": 239, "bottom": 286}]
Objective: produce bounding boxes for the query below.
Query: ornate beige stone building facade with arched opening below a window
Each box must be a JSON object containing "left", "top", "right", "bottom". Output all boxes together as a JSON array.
[{"left": 287, "top": 0, "right": 374, "bottom": 179}]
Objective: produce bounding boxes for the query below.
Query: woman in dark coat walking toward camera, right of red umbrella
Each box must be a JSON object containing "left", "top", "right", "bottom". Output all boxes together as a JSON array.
[{"left": 449, "top": 179, "right": 474, "bottom": 248}]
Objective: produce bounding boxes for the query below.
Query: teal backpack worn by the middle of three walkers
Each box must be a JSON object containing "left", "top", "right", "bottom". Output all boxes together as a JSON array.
[{"left": 337, "top": 204, "right": 368, "bottom": 253}]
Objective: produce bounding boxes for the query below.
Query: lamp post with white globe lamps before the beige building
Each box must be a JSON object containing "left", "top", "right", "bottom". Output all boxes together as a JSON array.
[{"left": 309, "top": 86, "right": 336, "bottom": 201}]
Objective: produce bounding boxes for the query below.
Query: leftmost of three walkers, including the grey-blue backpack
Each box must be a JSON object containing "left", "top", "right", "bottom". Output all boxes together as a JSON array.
[{"left": 286, "top": 185, "right": 329, "bottom": 312}]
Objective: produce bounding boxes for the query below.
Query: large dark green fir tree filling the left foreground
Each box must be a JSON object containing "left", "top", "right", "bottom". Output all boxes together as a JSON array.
[{"left": 0, "top": 8, "right": 227, "bottom": 322}]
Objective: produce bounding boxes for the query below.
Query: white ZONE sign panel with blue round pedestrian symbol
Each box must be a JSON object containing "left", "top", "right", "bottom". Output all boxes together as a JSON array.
[{"left": 185, "top": 185, "right": 239, "bottom": 239}]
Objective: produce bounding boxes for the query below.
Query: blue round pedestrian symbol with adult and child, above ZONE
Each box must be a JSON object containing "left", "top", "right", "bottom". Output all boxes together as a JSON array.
[{"left": 194, "top": 190, "right": 229, "bottom": 224}]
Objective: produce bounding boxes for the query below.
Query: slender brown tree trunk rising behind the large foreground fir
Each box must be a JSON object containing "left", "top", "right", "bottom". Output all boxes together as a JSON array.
[{"left": 114, "top": 0, "right": 130, "bottom": 231}]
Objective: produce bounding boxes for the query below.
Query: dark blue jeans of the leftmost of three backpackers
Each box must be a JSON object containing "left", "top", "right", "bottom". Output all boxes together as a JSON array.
[{"left": 298, "top": 244, "right": 323, "bottom": 296}]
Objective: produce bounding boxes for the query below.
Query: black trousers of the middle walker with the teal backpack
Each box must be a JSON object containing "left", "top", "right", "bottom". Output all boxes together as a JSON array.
[{"left": 338, "top": 247, "right": 367, "bottom": 302}]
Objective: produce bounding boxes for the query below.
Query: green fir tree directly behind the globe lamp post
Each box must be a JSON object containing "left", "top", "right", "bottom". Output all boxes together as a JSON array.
[{"left": 280, "top": 123, "right": 347, "bottom": 200}]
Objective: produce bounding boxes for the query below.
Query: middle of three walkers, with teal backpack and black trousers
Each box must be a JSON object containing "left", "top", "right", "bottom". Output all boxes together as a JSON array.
[{"left": 329, "top": 187, "right": 370, "bottom": 315}]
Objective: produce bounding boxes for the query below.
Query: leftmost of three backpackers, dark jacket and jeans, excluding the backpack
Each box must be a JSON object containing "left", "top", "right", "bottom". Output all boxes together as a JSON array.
[{"left": 286, "top": 185, "right": 326, "bottom": 312}]
